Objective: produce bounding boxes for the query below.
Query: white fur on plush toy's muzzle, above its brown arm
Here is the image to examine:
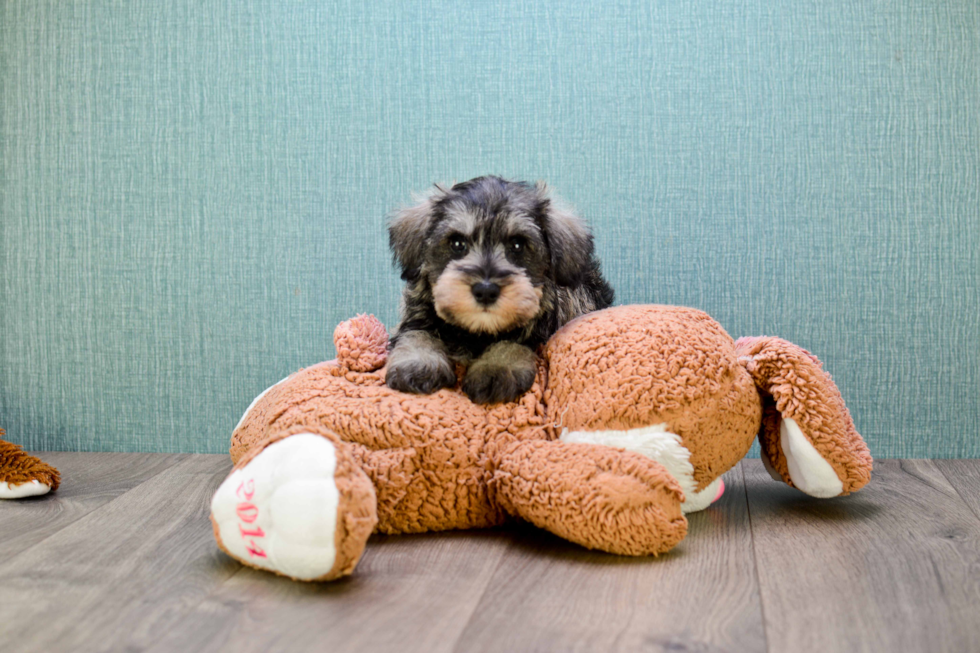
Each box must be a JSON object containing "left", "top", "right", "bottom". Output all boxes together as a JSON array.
[{"left": 560, "top": 423, "right": 721, "bottom": 513}]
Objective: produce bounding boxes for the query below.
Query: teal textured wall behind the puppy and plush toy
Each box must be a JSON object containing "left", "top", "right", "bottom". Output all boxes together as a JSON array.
[{"left": 0, "top": 0, "right": 980, "bottom": 457}]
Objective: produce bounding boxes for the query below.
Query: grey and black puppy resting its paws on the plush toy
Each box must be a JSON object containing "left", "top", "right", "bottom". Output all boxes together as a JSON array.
[{"left": 386, "top": 176, "right": 613, "bottom": 403}]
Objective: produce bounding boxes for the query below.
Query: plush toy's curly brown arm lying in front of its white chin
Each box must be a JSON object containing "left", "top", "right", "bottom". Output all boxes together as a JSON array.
[{"left": 492, "top": 440, "right": 687, "bottom": 555}]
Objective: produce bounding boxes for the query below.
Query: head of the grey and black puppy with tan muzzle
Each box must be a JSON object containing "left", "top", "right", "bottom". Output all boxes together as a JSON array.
[{"left": 389, "top": 177, "right": 593, "bottom": 334}]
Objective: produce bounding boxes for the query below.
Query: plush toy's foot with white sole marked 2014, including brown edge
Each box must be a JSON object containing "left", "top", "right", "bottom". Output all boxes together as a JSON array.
[{"left": 211, "top": 429, "right": 377, "bottom": 580}]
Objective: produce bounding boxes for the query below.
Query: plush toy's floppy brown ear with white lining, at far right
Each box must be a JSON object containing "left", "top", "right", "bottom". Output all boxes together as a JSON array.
[{"left": 735, "top": 337, "right": 871, "bottom": 498}]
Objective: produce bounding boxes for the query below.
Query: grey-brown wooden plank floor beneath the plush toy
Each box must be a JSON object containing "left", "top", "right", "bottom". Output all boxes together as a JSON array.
[{"left": 0, "top": 453, "right": 980, "bottom": 653}]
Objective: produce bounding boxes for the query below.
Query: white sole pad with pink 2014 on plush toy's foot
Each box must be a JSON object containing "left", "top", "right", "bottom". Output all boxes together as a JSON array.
[{"left": 211, "top": 433, "right": 340, "bottom": 580}]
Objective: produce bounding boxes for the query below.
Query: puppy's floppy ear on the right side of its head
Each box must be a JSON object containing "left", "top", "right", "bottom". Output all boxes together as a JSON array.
[{"left": 536, "top": 181, "right": 595, "bottom": 287}]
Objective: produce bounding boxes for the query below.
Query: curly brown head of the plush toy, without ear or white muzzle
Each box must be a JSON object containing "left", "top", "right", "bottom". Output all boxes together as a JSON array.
[{"left": 545, "top": 305, "right": 760, "bottom": 489}]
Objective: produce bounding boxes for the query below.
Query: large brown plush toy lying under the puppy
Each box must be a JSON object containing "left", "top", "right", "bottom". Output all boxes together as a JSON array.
[{"left": 211, "top": 306, "right": 871, "bottom": 580}]
